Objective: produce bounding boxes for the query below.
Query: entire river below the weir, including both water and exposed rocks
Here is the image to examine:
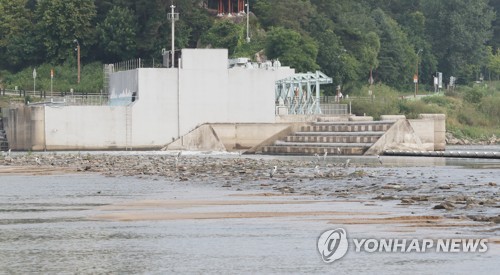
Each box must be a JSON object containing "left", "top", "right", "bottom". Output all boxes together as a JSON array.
[{"left": 0, "top": 153, "right": 500, "bottom": 274}]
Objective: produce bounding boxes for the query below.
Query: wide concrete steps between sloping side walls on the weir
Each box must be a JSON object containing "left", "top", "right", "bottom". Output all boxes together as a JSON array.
[{"left": 262, "top": 121, "right": 394, "bottom": 155}]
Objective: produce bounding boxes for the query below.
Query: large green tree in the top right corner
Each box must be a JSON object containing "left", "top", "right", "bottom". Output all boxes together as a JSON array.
[{"left": 422, "top": 0, "right": 495, "bottom": 80}]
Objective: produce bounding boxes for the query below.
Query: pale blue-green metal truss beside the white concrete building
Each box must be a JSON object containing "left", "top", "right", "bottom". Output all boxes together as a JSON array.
[{"left": 275, "top": 71, "right": 332, "bottom": 115}]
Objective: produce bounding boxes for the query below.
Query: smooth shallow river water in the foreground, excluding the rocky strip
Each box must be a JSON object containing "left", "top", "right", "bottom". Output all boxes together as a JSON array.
[{"left": 0, "top": 152, "right": 500, "bottom": 274}]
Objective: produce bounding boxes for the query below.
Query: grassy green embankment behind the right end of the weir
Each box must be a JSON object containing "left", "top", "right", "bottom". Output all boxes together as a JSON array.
[{"left": 352, "top": 82, "right": 500, "bottom": 140}]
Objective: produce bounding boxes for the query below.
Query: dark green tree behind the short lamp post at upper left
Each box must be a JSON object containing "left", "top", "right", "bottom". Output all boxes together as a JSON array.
[{"left": 36, "top": 0, "right": 96, "bottom": 62}]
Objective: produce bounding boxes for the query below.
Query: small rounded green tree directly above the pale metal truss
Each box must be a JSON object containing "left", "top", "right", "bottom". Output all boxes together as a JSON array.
[{"left": 266, "top": 27, "right": 319, "bottom": 72}]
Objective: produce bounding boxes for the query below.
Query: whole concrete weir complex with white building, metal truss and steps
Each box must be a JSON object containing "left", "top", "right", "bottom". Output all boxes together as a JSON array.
[{"left": 3, "top": 49, "right": 445, "bottom": 155}]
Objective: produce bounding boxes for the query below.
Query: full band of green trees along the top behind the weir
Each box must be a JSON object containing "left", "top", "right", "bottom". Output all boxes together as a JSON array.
[{"left": 0, "top": 0, "right": 500, "bottom": 94}]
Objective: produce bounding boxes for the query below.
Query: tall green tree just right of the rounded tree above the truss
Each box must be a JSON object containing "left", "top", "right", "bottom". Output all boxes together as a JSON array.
[{"left": 309, "top": 0, "right": 380, "bottom": 92}]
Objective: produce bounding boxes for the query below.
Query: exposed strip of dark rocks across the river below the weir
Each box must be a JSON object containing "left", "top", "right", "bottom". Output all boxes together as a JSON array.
[{"left": 0, "top": 152, "right": 500, "bottom": 224}]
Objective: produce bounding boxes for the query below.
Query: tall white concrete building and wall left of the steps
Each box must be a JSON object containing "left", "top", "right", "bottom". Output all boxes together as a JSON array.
[{"left": 4, "top": 49, "right": 295, "bottom": 150}]
